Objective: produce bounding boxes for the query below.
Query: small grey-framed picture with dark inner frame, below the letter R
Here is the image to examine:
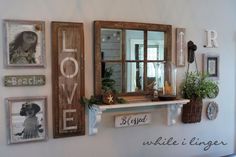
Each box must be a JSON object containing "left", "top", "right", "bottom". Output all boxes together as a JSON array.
[{"left": 203, "top": 54, "right": 219, "bottom": 80}]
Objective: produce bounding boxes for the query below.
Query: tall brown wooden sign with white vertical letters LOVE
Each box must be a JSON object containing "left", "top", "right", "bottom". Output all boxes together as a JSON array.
[{"left": 51, "top": 22, "right": 85, "bottom": 138}]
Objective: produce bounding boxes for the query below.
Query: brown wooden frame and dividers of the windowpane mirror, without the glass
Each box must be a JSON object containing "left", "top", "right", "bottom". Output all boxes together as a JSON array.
[{"left": 94, "top": 21, "right": 172, "bottom": 96}]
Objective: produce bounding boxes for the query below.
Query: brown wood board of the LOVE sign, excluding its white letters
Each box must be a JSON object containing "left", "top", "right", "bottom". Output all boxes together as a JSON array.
[{"left": 51, "top": 22, "right": 85, "bottom": 138}]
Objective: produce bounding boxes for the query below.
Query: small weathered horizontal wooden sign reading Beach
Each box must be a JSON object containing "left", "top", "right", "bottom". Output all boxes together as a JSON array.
[{"left": 4, "top": 75, "right": 46, "bottom": 87}]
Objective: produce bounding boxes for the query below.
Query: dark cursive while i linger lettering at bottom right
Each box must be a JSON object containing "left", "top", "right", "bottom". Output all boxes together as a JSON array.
[{"left": 143, "top": 137, "right": 227, "bottom": 151}]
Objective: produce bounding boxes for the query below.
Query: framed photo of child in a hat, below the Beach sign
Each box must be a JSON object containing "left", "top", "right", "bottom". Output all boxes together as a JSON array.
[{"left": 6, "top": 97, "right": 47, "bottom": 144}]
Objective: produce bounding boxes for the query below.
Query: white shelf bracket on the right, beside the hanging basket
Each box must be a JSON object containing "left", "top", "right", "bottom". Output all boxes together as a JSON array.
[{"left": 167, "top": 104, "right": 183, "bottom": 126}]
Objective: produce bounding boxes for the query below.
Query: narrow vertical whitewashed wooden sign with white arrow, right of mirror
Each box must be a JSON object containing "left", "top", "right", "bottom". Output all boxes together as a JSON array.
[{"left": 176, "top": 28, "right": 187, "bottom": 67}]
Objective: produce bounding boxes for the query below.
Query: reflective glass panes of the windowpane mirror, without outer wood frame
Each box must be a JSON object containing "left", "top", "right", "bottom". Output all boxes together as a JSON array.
[{"left": 101, "top": 29, "right": 164, "bottom": 93}]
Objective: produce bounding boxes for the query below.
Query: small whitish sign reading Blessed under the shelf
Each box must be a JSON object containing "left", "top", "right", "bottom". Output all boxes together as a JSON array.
[{"left": 115, "top": 113, "right": 151, "bottom": 128}]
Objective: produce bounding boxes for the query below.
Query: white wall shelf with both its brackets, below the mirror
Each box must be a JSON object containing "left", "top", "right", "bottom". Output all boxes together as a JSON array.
[{"left": 89, "top": 99, "right": 189, "bottom": 135}]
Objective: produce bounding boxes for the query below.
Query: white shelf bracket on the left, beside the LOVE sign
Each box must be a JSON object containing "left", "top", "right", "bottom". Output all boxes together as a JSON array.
[{"left": 89, "top": 105, "right": 102, "bottom": 135}]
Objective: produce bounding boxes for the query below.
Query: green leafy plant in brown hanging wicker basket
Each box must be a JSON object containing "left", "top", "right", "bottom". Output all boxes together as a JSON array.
[{"left": 181, "top": 72, "right": 219, "bottom": 123}]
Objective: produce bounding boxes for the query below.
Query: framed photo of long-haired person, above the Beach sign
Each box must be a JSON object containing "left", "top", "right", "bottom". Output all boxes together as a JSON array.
[{"left": 4, "top": 20, "right": 45, "bottom": 68}]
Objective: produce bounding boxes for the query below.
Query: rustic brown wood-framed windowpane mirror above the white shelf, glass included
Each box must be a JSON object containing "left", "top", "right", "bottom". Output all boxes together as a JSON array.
[{"left": 94, "top": 21, "right": 172, "bottom": 96}]
